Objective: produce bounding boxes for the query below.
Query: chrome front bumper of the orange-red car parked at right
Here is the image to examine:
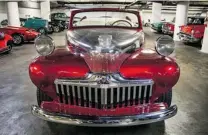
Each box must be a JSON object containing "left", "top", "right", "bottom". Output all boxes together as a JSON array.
[{"left": 177, "top": 32, "right": 200, "bottom": 43}]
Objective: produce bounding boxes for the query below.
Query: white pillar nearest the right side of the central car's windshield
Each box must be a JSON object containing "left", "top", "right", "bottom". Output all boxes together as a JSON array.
[{"left": 151, "top": 2, "right": 162, "bottom": 23}]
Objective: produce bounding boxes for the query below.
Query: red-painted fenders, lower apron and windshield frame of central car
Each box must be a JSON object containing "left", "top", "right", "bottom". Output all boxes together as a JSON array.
[{"left": 29, "top": 8, "right": 180, "bottom": 116}]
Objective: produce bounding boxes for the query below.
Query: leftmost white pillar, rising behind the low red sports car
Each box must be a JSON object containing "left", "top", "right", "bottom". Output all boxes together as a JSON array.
[{"left": 6, "top": 1, "right": 20, "bottom": 27}]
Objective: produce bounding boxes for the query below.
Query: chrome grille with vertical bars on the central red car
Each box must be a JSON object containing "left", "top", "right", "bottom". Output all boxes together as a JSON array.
[{"left": 54, "top": 74, "right": 154, "bottom": 109}]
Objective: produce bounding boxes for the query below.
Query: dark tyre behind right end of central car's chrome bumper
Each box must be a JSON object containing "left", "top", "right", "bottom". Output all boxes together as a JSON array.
[{"left": 156, "top": 89, "right": 172, "bottom": 107}]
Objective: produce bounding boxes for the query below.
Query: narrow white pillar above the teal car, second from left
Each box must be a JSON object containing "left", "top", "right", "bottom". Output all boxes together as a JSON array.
[{"left": 40, "top": 0, "right": 51, "bottom": 21}]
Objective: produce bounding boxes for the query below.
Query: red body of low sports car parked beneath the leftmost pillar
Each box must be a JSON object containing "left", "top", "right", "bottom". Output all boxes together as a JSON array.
[{"left": 0, "top": 26, "right": 39, "bottom": 41}]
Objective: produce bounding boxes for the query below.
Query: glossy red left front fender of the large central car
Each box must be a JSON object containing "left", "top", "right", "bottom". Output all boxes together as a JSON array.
[{"left": 29, "top": 48, "right": 90, "bottom": 98}]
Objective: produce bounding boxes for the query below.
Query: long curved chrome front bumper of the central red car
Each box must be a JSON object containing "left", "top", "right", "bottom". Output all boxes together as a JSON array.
[{"left": 31, "top": 105, "right": 177, "bottom": 127}]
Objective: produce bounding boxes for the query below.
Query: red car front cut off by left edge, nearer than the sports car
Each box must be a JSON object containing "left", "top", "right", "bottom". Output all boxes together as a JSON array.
[{"left": 0, "top": 34, "right": 12, "bottom": 53}]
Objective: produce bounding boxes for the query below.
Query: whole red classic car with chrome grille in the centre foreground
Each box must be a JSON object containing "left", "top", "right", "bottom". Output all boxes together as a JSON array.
[{"left": 29, "top": 8, "right": 180, "bottom": 126}]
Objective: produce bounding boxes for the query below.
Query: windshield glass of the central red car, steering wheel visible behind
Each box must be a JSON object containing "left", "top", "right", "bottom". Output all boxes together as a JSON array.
[{"left": 73, "top": 11, "right": 139, "bottom": 28}]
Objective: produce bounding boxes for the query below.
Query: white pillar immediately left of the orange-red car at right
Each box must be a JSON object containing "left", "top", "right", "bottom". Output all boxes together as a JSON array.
[{"left": 173, "top": 1, "right": 189, "bottom": 41}]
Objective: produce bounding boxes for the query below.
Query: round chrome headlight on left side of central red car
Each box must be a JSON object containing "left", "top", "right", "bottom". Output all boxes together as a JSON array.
[{"left": 35, "top": 35, "right": 55, "bottom": 56}]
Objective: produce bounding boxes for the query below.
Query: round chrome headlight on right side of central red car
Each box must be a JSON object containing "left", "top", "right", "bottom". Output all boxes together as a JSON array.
[{"left": 155, "top": 35, "right": 175, "bottom": 56}]
